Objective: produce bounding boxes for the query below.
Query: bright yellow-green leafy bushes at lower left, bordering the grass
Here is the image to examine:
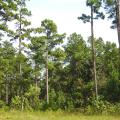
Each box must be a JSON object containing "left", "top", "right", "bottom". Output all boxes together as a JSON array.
[{"left": 11, "top": 86, "right": 41, "bottom": 110}]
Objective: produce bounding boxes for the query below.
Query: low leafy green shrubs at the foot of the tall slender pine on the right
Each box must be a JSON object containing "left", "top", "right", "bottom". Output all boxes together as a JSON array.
[{"left": 84, "top": 99, "right": 120, "bottom": 115}]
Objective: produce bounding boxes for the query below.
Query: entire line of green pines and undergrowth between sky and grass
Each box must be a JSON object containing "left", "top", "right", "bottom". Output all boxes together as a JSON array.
[{"left": 0, "top": 0, "right": 120, "bottom": 110}]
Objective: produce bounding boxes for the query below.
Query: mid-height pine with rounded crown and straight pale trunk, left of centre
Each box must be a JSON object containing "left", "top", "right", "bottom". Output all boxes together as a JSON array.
[{"left": 41, "top": 19, "right": 65, "bottom": 103}]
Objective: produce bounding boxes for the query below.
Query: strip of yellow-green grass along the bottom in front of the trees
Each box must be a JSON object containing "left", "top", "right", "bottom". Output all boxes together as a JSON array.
[{"left": 0, "top": 111, "right": 120, "bottom": 120}]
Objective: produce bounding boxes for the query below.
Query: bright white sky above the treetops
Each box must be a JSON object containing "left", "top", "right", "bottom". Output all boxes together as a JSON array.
[{"left": 27, "top": 0, "right": 118, "bottom": 44}]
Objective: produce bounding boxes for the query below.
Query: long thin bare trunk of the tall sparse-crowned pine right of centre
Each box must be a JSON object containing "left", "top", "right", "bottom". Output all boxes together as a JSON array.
[{"left": 91, "top": 5, "right": 98, "bottom": 99}]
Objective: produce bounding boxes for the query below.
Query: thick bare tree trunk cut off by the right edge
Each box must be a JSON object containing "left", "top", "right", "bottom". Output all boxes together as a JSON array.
[{"left": 116, "top": 0, "right": 120, "bottom": 80}]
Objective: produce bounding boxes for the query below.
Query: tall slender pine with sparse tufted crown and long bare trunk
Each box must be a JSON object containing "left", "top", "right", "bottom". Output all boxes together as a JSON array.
[{"left": 78, "top": 0, "right": 104, "bottom": 99}]
